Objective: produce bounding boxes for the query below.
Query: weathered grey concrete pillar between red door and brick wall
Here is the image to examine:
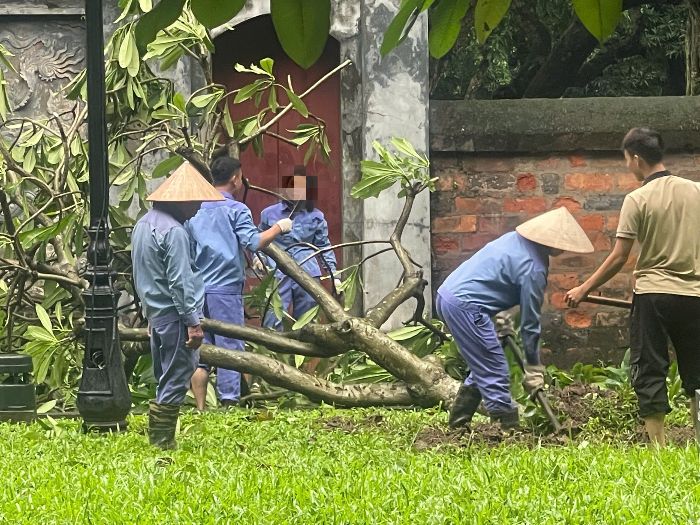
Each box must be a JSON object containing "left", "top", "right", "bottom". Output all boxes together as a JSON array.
[{"left": 360, "top": 0, "right": 431, "bottom": 328}]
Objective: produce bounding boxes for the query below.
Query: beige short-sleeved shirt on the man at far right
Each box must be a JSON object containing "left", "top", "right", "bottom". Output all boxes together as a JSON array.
[{"left": 618, "top": 175, "right": 700, "bottom": 296}]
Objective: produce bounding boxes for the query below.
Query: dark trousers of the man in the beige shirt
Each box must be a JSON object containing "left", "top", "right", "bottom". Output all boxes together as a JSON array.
[{"left": 630, "top": 293, "right": 700, "bottom": 417}]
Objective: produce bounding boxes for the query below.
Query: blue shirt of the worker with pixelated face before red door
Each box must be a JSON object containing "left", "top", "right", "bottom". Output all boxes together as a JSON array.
[{"left": 260, "top": 202, "right": 337, "bottom": 277}]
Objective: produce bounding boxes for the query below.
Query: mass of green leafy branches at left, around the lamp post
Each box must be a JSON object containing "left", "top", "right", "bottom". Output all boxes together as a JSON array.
[{"left": 0, "top": 0, "right": 336, "bottom": 406}]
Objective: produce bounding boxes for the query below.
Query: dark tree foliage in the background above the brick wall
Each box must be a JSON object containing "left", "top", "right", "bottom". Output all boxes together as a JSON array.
[{"left": 431, "top": 0, "right": 688, "bottom": 99}]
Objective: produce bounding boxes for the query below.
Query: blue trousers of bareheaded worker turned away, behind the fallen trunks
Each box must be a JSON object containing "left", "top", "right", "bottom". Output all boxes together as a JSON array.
[{"left": 200, "top": 289, "right": 245, "bottom": 401}]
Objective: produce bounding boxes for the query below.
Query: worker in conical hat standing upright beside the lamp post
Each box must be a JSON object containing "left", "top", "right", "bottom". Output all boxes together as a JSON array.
[{"left": 131, "top": 162, "right": 223, "bottom": 449}]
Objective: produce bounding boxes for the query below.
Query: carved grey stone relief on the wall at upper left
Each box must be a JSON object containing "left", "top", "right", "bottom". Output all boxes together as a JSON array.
[{"left": 0, "top": 18, "right": 85, "bottom": 117}]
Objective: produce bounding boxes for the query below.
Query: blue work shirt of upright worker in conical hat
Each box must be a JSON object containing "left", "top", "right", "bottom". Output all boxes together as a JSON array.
[{"left": 131, "top": 209, "right": 204, "bottom": 327}]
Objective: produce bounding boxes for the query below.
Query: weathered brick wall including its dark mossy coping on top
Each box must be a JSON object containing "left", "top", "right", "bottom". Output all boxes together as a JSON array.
[{"left": 431, "top": 99, "right": 700, "bottom": 366}]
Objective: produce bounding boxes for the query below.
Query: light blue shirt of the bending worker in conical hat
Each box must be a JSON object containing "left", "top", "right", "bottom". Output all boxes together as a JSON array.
[{"left": 438, "top": 232, "right": 549, "bottom": 364}]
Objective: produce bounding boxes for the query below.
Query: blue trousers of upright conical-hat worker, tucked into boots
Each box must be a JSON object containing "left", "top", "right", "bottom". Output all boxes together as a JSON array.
[{"left": 151, "top": 320, "right": 199, "bottom": 405}]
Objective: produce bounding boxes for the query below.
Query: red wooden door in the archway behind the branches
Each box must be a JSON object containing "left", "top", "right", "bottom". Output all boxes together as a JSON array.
[{"left": 213, "top": 15, "right": 342, "bottom": 254}]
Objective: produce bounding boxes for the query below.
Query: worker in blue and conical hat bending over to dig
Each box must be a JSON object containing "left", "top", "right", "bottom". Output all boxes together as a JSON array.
[{"left": 436, "top": 208, "right": 593, "bottom": 429}]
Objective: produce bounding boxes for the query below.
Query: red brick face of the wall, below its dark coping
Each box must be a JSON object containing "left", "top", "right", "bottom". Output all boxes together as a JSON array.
[{"left": 431, "top": 149, "right": 700, "bottom": 366}]
